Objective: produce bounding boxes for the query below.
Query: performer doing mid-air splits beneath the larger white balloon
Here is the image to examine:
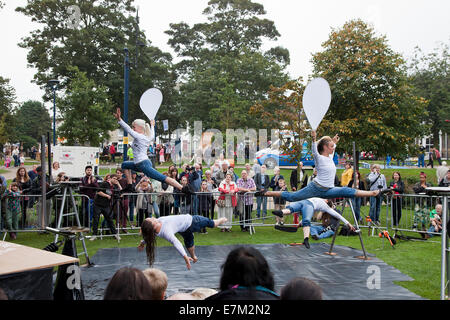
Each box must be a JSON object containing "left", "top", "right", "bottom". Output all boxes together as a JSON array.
[{"left": 255, "top": 130, "right": 390, "bottom": 202}]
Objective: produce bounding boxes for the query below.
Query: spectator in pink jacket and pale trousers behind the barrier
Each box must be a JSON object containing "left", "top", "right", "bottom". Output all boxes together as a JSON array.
[{"left": 217, "top": 173, "right": 238, "bottom": 232}]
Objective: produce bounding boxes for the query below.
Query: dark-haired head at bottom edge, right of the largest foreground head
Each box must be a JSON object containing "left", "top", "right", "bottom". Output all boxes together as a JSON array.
[{"left": 280, "top": 277, "right": 322, "bottom": 300}]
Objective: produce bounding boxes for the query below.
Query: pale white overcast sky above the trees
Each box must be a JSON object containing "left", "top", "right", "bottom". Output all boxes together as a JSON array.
[{"left": 0, "top": 0, "right": 450, "bottom": 107}]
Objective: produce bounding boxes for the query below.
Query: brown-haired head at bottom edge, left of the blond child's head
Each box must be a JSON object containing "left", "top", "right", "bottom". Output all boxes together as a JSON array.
[{"left": 103, "top": 267, "right": 153, "bottom": 300}]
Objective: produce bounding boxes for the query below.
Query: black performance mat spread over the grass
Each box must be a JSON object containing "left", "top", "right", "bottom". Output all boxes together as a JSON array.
[{"left": 81, "top": 243, "right": 422, "bottom": 300}]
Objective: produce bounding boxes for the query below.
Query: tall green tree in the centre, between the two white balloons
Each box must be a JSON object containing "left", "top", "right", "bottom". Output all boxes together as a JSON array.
[{"left": 166, "top": 0, "right": 289, "bottom": 130}]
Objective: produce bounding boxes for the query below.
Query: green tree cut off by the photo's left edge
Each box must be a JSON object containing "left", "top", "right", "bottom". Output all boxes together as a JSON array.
[{"left": 0, "top": 76, "right": 16, "bottom": 145}]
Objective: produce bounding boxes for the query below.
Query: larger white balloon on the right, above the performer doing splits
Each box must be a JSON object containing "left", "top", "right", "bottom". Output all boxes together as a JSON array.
[{"left": 303, "top": 78, "right": 331, "bottom": 130}]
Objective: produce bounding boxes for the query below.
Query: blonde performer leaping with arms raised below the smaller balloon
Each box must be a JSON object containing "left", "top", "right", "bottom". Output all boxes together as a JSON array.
[{"left": 114, "top": 108, "right": 188, "bottom": 193}]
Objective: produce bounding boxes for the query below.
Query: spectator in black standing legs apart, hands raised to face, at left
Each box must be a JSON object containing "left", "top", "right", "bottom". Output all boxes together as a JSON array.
[{"left": 89, "top": 174, "right": 122, "bottom": 241}]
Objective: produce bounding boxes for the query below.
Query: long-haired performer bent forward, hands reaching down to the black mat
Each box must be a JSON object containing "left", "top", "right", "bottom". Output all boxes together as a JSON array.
[{"left": 138, "top": 214, "right": 227, "bottom": 270}]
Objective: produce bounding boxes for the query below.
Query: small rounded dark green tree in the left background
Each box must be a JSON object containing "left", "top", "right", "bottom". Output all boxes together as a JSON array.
[{"left": 14, "top": 100, "right": 52, "bottom": 150}]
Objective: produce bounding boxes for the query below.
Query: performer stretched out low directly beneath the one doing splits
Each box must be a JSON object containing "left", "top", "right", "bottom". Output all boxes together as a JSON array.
[{"left": 272, "top": 198, "right": 355, "bottom": 249}]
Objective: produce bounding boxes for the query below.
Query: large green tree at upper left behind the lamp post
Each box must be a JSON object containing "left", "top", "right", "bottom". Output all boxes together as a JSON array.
[{"left": 16, "top": 0, "right": 176, "bottom": 125}]
